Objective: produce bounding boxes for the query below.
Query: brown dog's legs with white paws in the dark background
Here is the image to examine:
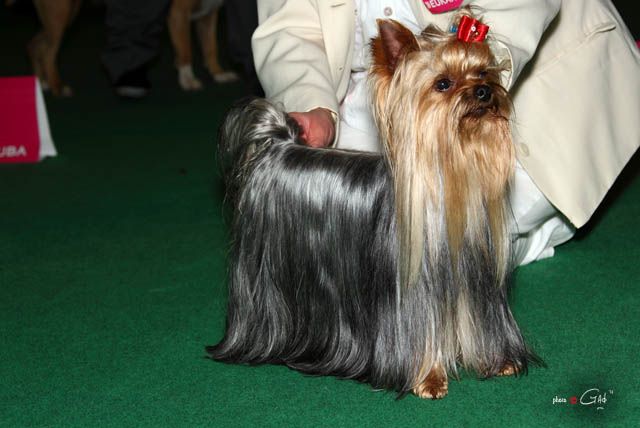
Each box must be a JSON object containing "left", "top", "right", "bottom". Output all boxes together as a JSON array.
[{"left": 168, "top": 0, "right": 238, "bottom": 91}]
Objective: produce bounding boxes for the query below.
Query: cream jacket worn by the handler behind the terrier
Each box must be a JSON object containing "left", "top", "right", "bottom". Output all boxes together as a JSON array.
[{"left": 252, "top": 0, "right": 640, "bottom": 227}]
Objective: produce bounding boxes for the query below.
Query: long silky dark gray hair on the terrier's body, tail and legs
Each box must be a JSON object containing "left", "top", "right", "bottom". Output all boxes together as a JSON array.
[{"left": 207, "top": 99, "right": 535, "bottom": 394}]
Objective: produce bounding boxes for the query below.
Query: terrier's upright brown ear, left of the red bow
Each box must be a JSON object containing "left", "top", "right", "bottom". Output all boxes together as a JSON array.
[{"left": 371, "top": 19, "right": 420, "bottom": 75}]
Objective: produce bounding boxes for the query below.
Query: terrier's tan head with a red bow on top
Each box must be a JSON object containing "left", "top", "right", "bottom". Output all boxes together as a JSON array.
[{"left": 370, "top": 14, "right": 511, "bottom": 159}]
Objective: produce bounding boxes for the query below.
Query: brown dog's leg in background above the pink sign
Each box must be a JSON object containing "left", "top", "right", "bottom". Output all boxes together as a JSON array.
[{"left": 20, "top": 0, "right": 82, "bottom": 97}]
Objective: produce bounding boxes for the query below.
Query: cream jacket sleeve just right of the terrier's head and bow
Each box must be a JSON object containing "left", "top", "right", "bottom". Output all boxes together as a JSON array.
[{"left": 465, "top": 0, "right": 561, "bottom": 88}]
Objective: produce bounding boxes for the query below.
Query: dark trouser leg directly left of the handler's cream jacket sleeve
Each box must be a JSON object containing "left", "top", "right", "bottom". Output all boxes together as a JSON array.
[{"left": 224, "top": 0, "right": 264, "bottom": 96}]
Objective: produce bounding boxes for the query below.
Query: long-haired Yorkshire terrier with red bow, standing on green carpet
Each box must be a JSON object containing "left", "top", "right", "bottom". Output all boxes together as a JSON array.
[{"left": 207, "top": 14, "right": 539, "bottom": 399}]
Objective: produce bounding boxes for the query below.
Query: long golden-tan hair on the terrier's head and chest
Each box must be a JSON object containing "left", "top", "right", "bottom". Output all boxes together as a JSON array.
[{"left": 370, "top": 17, "right": 514, "bottom": 285}]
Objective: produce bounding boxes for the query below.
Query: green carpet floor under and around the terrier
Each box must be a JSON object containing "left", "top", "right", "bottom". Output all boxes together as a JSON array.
[{"left": 0, "top": 7, "right": 640, "bottom": 427}]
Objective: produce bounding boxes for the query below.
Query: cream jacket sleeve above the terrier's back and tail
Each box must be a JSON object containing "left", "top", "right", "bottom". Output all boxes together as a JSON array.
[{"left": 252, "top": 0, "right": 338, "bottom": 112}]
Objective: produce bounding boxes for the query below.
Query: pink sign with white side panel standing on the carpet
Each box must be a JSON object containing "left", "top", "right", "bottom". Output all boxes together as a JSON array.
[{"left": 0, "top": 76, "right": 56, "bottom": 163}]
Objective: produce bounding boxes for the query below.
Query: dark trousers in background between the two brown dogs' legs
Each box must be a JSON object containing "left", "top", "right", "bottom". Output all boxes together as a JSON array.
[{"left": 102, "top": 0, "right": 171, "bottom": 81}]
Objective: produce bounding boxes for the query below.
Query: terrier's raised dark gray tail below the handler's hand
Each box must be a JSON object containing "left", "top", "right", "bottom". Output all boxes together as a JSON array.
[{"left": 218, "top": 97, "right": 300, "bottom": 195}]
